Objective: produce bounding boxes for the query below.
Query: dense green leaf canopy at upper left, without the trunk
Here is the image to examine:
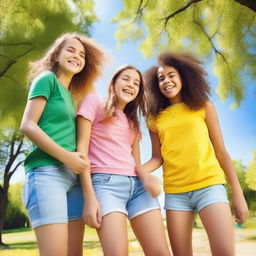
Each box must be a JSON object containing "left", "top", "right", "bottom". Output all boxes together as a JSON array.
[{"left": 0, "top": 0, "right": 96, "bottom": 123}]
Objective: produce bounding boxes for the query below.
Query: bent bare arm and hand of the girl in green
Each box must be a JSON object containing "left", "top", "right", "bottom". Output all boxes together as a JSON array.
[{"left": 20, "top": 97, "right": 88, "bottom": 173}]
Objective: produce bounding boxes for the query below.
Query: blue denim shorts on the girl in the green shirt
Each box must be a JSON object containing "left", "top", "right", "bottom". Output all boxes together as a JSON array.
[{"left": 23, "top": 165, "right": 84, "bottom": 228}]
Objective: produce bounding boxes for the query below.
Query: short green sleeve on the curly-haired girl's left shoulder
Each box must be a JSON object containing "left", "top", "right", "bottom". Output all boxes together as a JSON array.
[{"left": 28, "top": 71, "right": 55, "bottom": 100}]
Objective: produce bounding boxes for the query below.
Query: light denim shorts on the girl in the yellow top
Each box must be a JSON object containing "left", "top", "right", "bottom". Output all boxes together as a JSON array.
[{"left": 164, "top": 184, "right": 229, "bottom": 212}]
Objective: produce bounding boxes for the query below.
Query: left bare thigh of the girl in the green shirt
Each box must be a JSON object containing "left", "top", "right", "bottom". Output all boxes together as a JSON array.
[{"left": 35, "top": 224, "right": 68, "bottom": 256}]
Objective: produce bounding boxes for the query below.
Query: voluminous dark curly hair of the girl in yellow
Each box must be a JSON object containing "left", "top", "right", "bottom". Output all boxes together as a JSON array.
[{"left": 143, "top": 52, "right": 211, "bottom": 116}]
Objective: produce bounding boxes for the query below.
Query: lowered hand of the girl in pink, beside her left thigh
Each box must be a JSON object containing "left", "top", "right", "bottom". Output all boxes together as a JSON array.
[{"left": 83, "top": 197, "right": 102, "bottom": 229}]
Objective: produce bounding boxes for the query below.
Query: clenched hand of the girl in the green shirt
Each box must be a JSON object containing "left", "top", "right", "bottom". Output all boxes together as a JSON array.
[{"left": 63, "top": 152, "right": 90, "bottom": 174}]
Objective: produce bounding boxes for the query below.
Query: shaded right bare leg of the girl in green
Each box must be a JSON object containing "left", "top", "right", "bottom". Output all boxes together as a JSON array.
[{"left": 68, "top": 220, "right": 84, "bottom": 256}]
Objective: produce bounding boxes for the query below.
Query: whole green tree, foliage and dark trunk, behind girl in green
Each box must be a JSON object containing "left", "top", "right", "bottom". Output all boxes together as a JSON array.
[{"left": 0, "top": 0, "right": 97, "bottom": 245}]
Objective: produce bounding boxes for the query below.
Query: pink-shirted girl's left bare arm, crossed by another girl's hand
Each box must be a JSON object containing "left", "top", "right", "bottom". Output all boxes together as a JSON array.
[{"left": 77, "top": 116, "right": 101, "bottom": 228}]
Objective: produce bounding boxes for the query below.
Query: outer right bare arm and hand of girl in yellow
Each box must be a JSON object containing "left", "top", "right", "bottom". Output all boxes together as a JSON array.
[{"left": 205, "top": 102, "right": 248, "bottom": 223}]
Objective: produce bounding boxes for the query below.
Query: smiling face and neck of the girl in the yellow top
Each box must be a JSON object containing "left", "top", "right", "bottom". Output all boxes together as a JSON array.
[{"left": 157, "top": 66, "right": 182, "bottom": 104}]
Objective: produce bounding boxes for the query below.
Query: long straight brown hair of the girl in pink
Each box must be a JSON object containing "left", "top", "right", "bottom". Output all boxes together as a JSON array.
[{"left": 103, "top": 65, "right": 145, "bottom": 132}]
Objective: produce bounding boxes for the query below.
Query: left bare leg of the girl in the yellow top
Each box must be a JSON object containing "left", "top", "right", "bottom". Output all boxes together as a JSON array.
[{"left": 166, "top": 210, "right": 194, "bottom": 256}]
